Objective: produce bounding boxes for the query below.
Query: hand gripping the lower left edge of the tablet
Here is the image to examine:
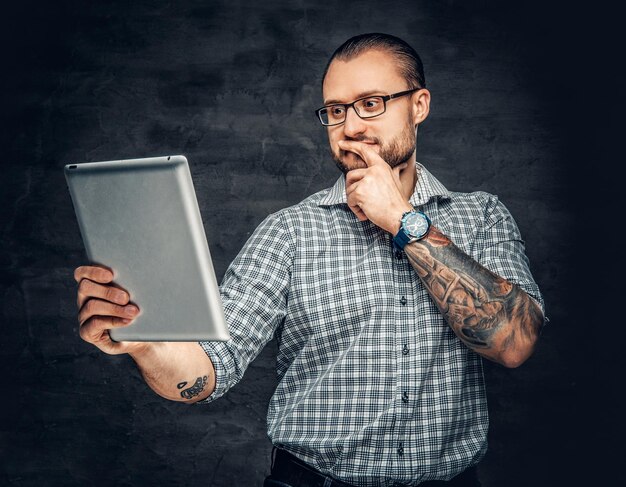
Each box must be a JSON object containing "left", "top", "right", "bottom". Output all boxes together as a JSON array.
[{"left": 74, "top": 266, "right": 147, "bottom": 355}]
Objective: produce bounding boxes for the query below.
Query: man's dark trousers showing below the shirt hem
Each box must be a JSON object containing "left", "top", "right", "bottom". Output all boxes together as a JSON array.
[{"left": 263, "top": 448, "right": 480, "bottom": 487}]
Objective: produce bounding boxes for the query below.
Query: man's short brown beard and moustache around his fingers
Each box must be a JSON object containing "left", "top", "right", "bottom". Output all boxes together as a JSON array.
[{"left": 330, "top": 117, "right": 417, "bottom": 174}]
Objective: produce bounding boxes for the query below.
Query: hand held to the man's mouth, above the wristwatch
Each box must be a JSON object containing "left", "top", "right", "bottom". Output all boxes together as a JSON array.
[{"left": 338, "top": 140, "right": 413, "bottom": 235}]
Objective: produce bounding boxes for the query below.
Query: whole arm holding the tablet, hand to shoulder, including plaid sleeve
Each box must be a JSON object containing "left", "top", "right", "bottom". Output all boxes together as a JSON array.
[{"left": 74, "top": 210, "right": 292, "bottom": 402}]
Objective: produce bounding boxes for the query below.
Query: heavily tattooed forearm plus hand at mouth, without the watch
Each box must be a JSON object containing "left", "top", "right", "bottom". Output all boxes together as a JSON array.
[{"left": 340, "top": 141, "right": 543, "bottom": 367}]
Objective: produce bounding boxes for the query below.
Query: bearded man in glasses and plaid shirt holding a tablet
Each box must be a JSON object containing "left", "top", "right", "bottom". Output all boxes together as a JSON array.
[{"left": 75, "top": 34, "right": 543, "bottom": 486}]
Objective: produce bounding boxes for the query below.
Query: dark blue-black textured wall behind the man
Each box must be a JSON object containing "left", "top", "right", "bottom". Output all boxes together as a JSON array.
[{"left": 0, "top": 0, "right": 624, "bottom": 487}]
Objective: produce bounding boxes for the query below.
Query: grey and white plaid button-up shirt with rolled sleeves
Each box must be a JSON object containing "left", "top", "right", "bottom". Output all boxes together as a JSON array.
[{"left": 201, "top": 164, "right": 543, "bottom": 486}]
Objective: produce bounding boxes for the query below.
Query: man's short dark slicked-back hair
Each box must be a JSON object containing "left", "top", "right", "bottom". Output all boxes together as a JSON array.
[{"left": 322, "top": 33, "right": 426, "bottom": 88}]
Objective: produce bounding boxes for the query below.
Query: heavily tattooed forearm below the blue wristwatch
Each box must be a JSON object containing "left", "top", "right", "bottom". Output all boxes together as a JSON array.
[{"left": 405, "top": 226, "right": 543, "bottom": 367}]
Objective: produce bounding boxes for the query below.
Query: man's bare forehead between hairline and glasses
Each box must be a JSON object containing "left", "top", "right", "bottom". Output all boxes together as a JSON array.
[{"left": 322, "top": 50, "right": 406, "bottom": 102}]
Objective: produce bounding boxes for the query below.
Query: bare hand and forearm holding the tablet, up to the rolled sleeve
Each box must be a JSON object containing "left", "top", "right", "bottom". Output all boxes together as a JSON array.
[{"left": 74, "top": 266, "right": 215, "bottom": 403}]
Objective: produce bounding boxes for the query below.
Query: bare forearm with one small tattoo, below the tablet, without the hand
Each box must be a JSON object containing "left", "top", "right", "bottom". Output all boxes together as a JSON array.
[{"left": 130, "top": 342, "right": 215, "bottom": 403}]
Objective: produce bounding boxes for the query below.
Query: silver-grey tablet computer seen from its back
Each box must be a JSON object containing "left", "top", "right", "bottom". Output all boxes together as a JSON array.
[{"left": 64, "top": 155, "right": 230, "bottom": 341}]
